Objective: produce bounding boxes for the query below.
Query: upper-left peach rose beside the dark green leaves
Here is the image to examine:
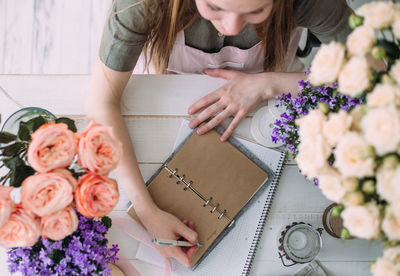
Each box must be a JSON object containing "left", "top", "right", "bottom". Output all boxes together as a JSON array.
[{"left": 28, "top": 123, "right": 76, "bottom": 172}]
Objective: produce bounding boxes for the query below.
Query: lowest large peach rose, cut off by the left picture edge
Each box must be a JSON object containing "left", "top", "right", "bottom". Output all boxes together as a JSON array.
[{"left": 0, "top": 204, "right": 40, "bottom": 248}]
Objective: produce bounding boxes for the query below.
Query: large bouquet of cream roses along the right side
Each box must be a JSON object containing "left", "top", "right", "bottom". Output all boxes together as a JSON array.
[{"left": 296, "top": 2, "right": 400, "bottom": 275}]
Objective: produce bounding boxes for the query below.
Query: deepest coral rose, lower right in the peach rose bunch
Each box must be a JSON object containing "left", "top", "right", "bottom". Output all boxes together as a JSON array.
[{"left": 75, "top": 172, "right": 119, "bottom": 218}]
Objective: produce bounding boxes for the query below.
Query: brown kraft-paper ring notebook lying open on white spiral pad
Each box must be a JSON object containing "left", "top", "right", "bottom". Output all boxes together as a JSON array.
[{"left": 128, "top": 126, "right": 273, "bottom": 266}]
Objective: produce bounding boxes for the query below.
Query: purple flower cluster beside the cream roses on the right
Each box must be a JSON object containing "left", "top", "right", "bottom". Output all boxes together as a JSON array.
[{"left": 272, "top": 76, "right": 363, "bottom": 156}]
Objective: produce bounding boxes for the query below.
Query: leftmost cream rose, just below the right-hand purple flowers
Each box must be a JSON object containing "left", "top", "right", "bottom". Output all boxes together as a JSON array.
[{"left": 296, "top": 135, "right": 332, "bottom": 179}]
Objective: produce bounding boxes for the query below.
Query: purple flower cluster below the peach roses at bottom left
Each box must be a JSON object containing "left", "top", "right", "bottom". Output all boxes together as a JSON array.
[{"left": 7, "top": 212, "right": 119, "bottom": 275}]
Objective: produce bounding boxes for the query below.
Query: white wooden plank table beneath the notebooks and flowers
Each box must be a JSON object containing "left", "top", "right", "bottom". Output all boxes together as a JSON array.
[{"left": 0, "top": 75, "right": 382, "bottom": 275}]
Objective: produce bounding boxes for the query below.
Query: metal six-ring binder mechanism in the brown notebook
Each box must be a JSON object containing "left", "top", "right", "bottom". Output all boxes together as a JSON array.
[{"left": 164, "top": 165, "right": 235, "bottom": 224}]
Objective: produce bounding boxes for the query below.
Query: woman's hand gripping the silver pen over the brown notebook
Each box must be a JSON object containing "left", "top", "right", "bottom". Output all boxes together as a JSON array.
[{"left": 139, "top": 207, "right": 198, "bottom": 267}]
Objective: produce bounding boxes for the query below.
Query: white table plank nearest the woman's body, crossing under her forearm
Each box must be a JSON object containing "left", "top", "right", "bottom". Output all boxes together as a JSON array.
[{"left": 0, "top": 75, "right": 267, "bottom": 116}]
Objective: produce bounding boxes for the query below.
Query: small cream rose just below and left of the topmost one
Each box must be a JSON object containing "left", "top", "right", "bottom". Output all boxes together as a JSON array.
[{"left": 346, "top": 26, "right": 376, "bottom": 56}]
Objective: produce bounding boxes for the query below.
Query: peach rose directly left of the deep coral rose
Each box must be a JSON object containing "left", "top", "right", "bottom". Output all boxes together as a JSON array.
[{"left": 21, "top": 169, "right": 77, "bottom": 217}]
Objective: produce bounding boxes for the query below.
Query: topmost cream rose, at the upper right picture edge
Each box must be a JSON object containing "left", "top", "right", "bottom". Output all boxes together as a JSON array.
[{"left": 356, "top": 2, "right": 394, "bottom": 29}]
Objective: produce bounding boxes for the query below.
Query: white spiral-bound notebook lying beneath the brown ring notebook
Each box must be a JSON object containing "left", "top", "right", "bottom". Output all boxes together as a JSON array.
[{"left": 136, "top": 120, "right": 285, "bottom": 276}]
